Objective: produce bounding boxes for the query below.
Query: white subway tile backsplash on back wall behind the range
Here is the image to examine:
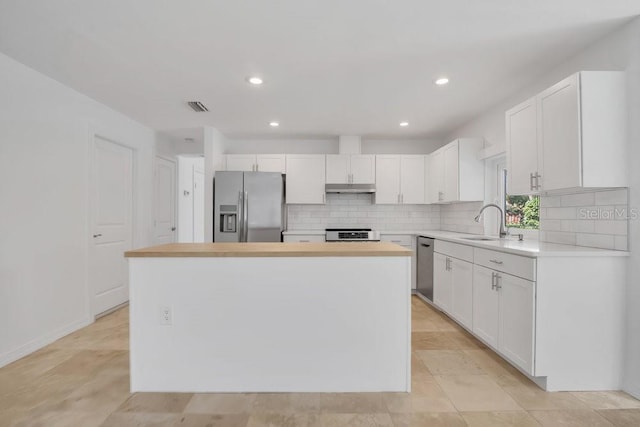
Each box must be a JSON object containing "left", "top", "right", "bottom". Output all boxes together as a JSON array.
[{"left": 287, "top": 194, "right": 440, "bottom": 231}]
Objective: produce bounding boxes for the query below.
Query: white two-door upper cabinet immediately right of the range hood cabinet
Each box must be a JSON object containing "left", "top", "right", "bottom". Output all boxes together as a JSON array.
[{"left": 375, "top": 154, "right": 425, "bottom": 204}]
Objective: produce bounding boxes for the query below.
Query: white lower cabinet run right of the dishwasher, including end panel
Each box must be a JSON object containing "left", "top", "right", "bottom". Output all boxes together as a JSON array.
[{"left": 433, "top": 238, "right": 626, "bottom": 391}]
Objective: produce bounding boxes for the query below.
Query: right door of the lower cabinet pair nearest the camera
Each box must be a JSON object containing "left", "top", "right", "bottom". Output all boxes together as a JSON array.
[{"left": 497, "top": 273, "right": 535, "bottom": 375}]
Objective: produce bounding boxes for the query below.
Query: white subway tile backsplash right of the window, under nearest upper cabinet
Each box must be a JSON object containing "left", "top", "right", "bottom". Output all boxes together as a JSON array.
[{"left": 540, "top": 188, "right": 634, "bottom": 250}]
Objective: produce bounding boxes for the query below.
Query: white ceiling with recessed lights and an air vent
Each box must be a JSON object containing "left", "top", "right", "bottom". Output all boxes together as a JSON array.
[{"left": 0, "top": 0, "right": 640, "bottom": 138}]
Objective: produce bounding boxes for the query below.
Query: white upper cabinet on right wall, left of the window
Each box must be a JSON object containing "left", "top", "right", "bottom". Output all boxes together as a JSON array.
[{"left": 427, "top": 138, "right": 484, "bottom": 203}]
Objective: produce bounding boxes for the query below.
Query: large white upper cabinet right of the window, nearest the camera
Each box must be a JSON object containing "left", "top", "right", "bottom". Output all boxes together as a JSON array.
[{"left": 506, "top": 71, "right": 628, "bottom": 194}]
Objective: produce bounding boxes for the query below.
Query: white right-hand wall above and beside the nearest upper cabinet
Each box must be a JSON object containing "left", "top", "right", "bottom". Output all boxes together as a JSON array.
[{"left": 442, "top": 18, "right": 640, "bottom": 397}]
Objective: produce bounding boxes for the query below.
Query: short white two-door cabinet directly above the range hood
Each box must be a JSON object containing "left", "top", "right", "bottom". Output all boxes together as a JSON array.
[{"left": 327, "top": 154, "right": 376, "bottom": 184}]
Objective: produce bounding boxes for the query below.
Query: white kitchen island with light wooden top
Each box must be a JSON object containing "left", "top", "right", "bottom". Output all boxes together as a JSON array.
[{"left": 125, "top": 243, "right": 411, "bottom": 392}]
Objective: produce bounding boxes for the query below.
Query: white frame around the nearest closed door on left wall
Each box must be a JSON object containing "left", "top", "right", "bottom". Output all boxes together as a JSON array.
[{"left": 84, "top": 125, "right": 140, "bottom": 322}]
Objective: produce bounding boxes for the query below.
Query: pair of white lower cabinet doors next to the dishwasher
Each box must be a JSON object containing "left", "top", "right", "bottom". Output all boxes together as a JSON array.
[{"left": 433, "top": 252, "right": 473, "bottom": 329}]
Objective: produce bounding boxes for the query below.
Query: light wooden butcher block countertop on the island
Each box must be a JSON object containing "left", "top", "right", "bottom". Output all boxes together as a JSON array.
[{"left": 124, "top": 242, "right": 411, "bottom": 258}]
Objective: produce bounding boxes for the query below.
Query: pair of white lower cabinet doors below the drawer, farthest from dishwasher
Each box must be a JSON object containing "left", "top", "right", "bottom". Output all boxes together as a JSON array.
[{"left": 473, "top": 265, "right": 535, "bottom": 375}]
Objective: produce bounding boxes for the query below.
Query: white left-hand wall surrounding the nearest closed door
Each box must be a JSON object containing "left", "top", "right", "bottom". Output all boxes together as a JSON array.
[{"left": 0, "top": 49, "right": 155, "bottom": 366}]
